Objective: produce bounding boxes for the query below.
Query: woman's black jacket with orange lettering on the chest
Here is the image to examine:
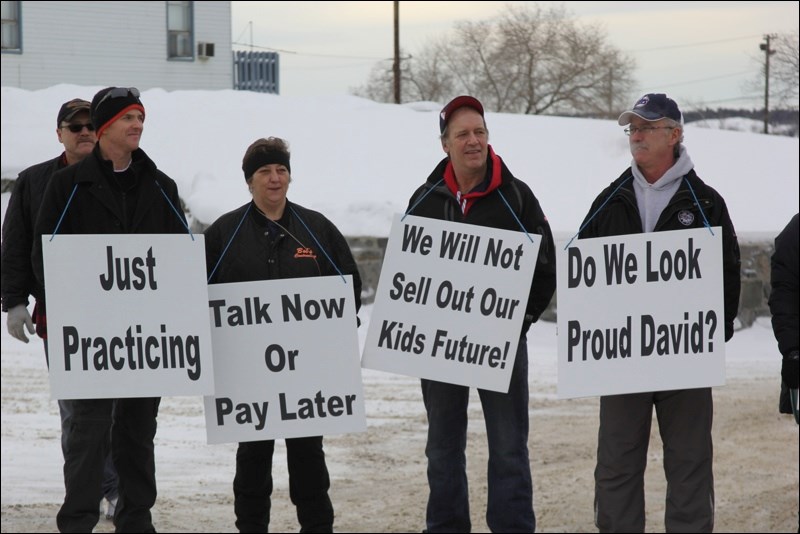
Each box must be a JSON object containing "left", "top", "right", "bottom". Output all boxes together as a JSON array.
[{"left": 203, "top": 200, "right": 361, "bottom": 311}]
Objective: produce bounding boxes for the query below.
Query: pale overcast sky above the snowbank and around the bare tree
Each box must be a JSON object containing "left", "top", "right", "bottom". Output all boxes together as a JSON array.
[{"left": 231, "top": 1, "right": 800, "bottom": 109}]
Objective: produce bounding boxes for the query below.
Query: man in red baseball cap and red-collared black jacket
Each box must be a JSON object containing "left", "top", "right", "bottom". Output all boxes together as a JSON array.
[{"left": 408, "top": 95, "right": 556, "bottom": 532}]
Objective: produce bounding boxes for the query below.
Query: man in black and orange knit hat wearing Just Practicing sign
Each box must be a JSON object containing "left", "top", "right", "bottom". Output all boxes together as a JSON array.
[{"left": 32, "top": 87, "right": 188, "bottom": 532}]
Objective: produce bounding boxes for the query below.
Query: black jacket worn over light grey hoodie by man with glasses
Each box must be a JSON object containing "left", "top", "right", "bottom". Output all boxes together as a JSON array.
[{"left": 579, "top": 167, "right": 741, "bottom": 341}]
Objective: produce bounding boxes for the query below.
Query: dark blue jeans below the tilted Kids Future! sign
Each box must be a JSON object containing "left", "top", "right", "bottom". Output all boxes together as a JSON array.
[{"left": 422, "top": 336, "right": 536, "bottom": 532}]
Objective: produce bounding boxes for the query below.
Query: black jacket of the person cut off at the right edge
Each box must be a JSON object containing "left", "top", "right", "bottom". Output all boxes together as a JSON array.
[{"left": 769, "top": 214, "right": 800, "bottom": 356}]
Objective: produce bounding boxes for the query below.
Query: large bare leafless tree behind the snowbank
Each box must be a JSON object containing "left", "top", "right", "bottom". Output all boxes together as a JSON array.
[{"left": 356, "top": 4, "right": 635, "bottom": 117}]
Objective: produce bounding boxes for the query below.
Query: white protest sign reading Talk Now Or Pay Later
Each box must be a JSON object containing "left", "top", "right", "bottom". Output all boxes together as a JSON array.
[{"left": 203, "top": 275, "right": 367, "bottom": 443}]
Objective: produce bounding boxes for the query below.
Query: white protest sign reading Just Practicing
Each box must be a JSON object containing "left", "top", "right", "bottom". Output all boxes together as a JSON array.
[{"left": 42, "top": 234, "right": 214, "bottom": 399}]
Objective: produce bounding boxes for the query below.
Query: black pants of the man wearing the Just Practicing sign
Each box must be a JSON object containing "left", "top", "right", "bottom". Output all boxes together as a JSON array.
[{"left": 56, "top": 397, "right": 161, "bottom": 532}]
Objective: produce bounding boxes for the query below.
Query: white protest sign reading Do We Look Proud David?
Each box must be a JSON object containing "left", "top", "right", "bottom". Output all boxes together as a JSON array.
[{"left": 556, "top": 227, "right": 725, "bottom": 398}]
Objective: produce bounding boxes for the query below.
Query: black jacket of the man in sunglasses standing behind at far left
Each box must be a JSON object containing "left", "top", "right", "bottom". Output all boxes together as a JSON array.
[{"left": 0, "top": 153, "right": 67, "bottom": 319}]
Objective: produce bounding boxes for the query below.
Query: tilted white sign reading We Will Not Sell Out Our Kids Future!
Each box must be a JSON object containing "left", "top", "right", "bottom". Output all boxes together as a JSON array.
[{"left": 361, "top": 215, "right": 541, "bottom": 392}]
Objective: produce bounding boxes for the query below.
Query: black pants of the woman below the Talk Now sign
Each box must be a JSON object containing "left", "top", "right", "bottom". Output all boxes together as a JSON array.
[{"left": 233, "top": 436, "right": 333, "bottom": 532}]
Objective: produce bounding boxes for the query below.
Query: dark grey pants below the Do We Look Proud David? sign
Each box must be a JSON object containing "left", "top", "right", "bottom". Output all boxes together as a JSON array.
[{"left": 594, "top": 388, "right": 714, "bottom": 532}]
